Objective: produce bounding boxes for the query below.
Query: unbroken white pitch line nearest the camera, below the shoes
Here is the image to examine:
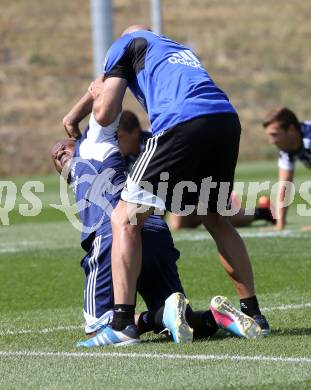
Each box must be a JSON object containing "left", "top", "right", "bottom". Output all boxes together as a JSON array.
[{"left": 0, "top": 351, "right": 311, "bottom": 364}]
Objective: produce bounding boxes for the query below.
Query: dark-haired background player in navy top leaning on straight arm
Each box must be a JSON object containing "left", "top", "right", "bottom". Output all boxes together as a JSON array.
[{"left": 263, "top": 107, "right": 311, "bottom": 230}]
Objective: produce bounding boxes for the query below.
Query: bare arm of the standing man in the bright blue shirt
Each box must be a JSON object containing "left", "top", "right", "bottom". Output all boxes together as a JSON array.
[{"left": 89, "top": 76, "right": 127, "bottom": 126}]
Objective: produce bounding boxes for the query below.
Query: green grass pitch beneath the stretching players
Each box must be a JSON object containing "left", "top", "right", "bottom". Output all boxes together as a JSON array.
[{"left": 0, "top": 163, "right": 311, "bottom": 389}]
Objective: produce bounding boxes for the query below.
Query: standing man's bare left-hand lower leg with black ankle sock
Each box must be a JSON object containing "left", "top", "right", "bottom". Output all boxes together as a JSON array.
[{"left": 111, "top": 200, "right": 153, "bottom": 330}]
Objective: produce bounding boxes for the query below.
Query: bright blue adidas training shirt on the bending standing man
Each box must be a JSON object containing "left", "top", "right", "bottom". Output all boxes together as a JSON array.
[{"left": 103, "top": 30, "right": 236, "bottom": 135}]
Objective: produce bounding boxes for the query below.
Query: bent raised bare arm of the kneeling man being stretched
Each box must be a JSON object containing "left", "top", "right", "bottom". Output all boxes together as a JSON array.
[{"left": 63, "top": 91, "right": 93, "bottom": 139}]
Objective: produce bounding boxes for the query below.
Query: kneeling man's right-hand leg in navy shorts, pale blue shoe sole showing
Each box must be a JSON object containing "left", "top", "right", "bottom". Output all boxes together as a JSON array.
[{"left": 137, "top": 224, "right": 193, "bottom": 343}]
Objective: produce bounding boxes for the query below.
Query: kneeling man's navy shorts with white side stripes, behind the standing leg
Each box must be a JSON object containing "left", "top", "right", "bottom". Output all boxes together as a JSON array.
[{"left": 81, "top": 228, "right": 184, "bottom": 318}]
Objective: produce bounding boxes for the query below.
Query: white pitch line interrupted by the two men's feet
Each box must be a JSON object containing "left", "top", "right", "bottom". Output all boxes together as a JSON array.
[{"left": 0, "top": 302, "right": 311, "bottom": 337}]
